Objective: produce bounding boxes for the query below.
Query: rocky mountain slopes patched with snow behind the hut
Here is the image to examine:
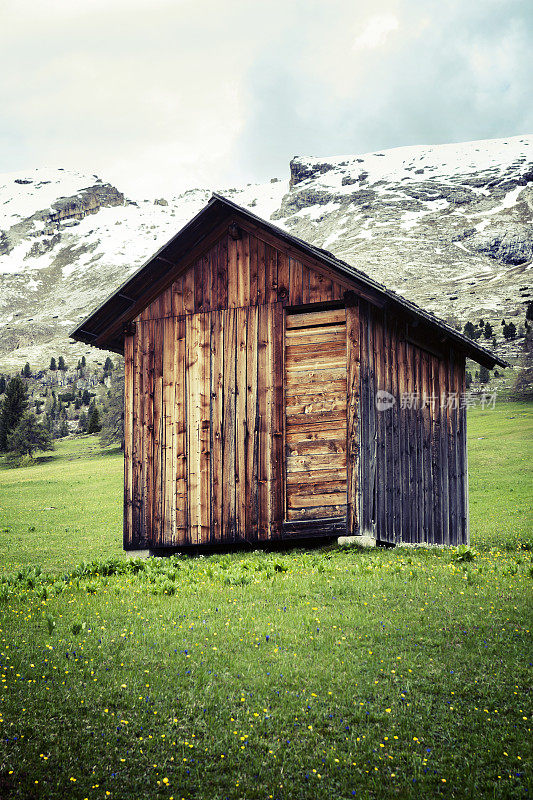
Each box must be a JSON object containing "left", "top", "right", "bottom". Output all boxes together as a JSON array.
[{"left": 0, "top": 136, "right": 533, "bottom": 369}]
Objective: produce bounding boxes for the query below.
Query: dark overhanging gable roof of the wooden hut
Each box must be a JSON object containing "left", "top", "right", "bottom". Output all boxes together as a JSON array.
[{"left": 70, "top": 194, "right": 509, "bottom": 369}]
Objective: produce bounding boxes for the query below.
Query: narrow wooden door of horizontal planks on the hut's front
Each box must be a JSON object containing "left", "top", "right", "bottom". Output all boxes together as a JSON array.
[{"left": 285, "top": 308, "right": 346, "bottom": 523}]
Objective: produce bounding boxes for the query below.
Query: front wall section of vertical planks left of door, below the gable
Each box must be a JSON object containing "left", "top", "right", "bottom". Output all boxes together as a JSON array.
[{"left": 124, "top": 303, "right": 283, "bottom": 548}]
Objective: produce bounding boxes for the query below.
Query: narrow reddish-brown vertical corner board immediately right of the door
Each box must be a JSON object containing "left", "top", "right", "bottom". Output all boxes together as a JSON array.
[{"left": 346, "top": 300, "right": 361, "bottom": 536}]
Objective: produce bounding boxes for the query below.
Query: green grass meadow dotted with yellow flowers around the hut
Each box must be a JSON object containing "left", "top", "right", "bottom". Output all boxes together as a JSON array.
[{"left": 0, "top": 403, "right": 533, "bottom": 800}]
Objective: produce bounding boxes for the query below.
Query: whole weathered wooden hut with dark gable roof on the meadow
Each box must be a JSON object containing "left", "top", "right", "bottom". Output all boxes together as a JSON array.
[{"left": 72, "top": 195, "right": 505, "bottom": 552}]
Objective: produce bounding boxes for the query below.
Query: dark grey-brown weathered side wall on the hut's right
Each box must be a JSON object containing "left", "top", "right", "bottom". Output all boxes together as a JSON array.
[{"left": 357, "top": 300, "right": 468, "bottom": 545}]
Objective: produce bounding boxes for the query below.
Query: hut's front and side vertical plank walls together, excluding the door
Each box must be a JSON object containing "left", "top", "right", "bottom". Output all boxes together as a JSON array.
[{"left": 124, "top": 225, "right": 468, "bottom": 549}]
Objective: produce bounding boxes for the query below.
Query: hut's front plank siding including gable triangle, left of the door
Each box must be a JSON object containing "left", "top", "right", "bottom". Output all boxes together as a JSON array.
[{"left": 124, "top": 230, "right": 346, "bottom": 548}]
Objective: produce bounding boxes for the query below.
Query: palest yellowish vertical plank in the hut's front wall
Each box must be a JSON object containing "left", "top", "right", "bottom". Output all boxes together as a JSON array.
[{"left": 185, "top": 314, "right": 201, "bottom": 544}]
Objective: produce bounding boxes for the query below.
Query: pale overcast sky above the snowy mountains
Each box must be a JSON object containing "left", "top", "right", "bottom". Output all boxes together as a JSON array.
[{"left": 0, "top": 0, "right": 533, "bottom": 195}]
